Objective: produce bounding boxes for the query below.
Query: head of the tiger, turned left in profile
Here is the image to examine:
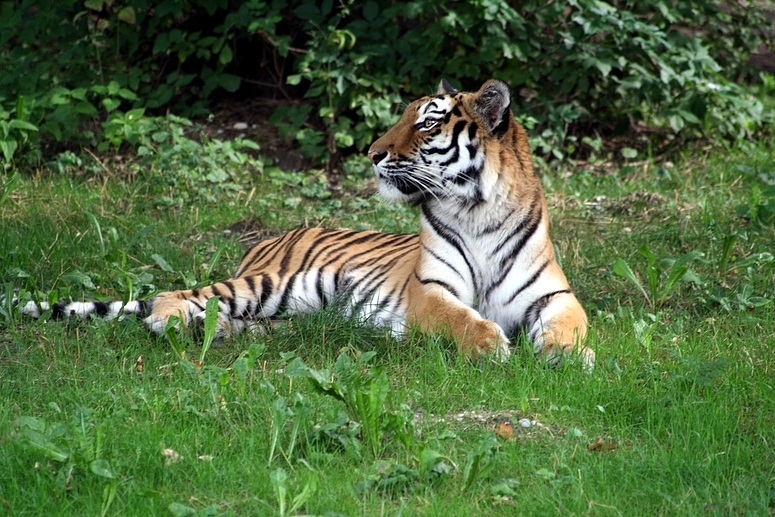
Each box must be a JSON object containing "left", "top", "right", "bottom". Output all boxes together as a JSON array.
[{"left": 368, "top": 79, "right": 532, "bottom": 204}]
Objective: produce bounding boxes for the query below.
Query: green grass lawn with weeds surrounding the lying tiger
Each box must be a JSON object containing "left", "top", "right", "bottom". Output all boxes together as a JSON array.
[{"left": 0, "top": 135, "right": 775, "bottom": 516}]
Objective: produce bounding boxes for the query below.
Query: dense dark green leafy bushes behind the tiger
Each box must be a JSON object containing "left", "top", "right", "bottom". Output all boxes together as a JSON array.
[{"left": 0, "top": 0, "right": 772, "bottom": 169}]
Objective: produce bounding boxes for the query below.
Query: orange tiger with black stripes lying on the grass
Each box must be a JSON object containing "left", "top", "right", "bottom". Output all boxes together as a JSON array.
[{"left": 15, "top": 79, "right": 595, "bottom": 369}]
